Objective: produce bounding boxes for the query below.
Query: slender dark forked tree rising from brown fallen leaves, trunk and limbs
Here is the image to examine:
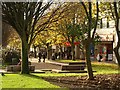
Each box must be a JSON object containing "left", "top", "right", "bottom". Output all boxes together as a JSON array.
[{"left": 80, "top": 0, "right": 99, "bottom": 79}]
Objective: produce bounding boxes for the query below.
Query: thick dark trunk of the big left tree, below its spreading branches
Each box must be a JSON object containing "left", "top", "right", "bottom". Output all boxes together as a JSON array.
[{"left": 21, "top": 41, "right": 29, "bottom": 74}]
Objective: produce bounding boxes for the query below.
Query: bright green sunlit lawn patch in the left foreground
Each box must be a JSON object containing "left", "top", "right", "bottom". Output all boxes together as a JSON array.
[{"left": 2, "top": 74, "right": 59, "bottom": 88}]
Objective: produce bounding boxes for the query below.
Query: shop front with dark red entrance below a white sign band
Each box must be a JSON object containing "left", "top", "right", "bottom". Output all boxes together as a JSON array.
[{"left": 95, "top": 34, "right": 113, "bottom": 61}]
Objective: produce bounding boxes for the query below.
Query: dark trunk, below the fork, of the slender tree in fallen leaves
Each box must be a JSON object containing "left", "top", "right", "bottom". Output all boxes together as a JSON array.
[{"left": 86, "top": 39, "right": 94, "bottom": 80}]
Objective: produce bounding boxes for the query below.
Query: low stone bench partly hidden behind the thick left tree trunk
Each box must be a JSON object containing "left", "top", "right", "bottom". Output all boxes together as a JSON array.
[{"left": 6, "top": 65, "right": 35, "bottom": 72}]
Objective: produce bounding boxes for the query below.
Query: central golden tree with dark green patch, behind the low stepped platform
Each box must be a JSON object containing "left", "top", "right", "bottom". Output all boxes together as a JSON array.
[{"left": 51, "top": 2, "right": 85, "bottom": 60}]
